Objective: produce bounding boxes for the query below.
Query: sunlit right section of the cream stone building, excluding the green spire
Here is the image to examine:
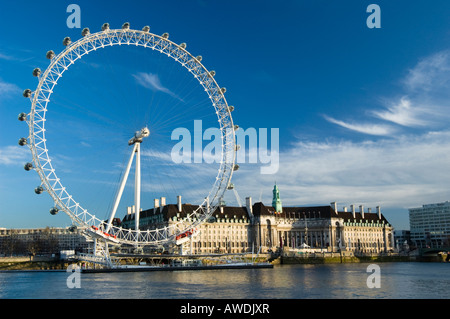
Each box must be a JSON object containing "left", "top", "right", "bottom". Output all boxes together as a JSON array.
[{"left": 253, "top": 203, "right": 394, "bottom": 253}]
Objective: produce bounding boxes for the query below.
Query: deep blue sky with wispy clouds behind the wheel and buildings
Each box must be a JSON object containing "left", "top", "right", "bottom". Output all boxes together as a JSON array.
[{"left": 0, "top": 0, "right": 450, "bottom": 229}]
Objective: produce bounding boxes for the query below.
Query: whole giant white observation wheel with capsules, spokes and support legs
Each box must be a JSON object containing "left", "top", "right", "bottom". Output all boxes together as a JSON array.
[{"left": 19, "top": 23, "right": 238, "bottom": 246}]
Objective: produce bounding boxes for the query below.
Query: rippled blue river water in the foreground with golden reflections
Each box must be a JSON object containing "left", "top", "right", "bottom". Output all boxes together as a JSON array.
[{"left": 0, "top": 262, "right": 450, "bottom": 299}]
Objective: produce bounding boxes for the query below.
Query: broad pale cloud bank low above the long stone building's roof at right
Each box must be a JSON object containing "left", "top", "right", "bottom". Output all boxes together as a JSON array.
[{"left": 233, "top": 131, "right": 450, "bottom": 211}]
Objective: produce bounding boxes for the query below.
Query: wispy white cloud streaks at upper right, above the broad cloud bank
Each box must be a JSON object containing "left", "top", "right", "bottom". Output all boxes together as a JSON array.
[{"left": 325, "top": 51, "right": 450, "bottom": 136}]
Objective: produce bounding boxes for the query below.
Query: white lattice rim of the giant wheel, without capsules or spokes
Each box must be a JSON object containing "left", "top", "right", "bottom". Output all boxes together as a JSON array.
[{"left": 27, "top": 27, "right": 236, "bottom": 245}]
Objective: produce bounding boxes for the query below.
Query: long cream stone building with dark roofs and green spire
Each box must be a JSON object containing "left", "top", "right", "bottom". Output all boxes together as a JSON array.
[{"left": 122, "top": 185, "right": 394, "bottom": 254}]
